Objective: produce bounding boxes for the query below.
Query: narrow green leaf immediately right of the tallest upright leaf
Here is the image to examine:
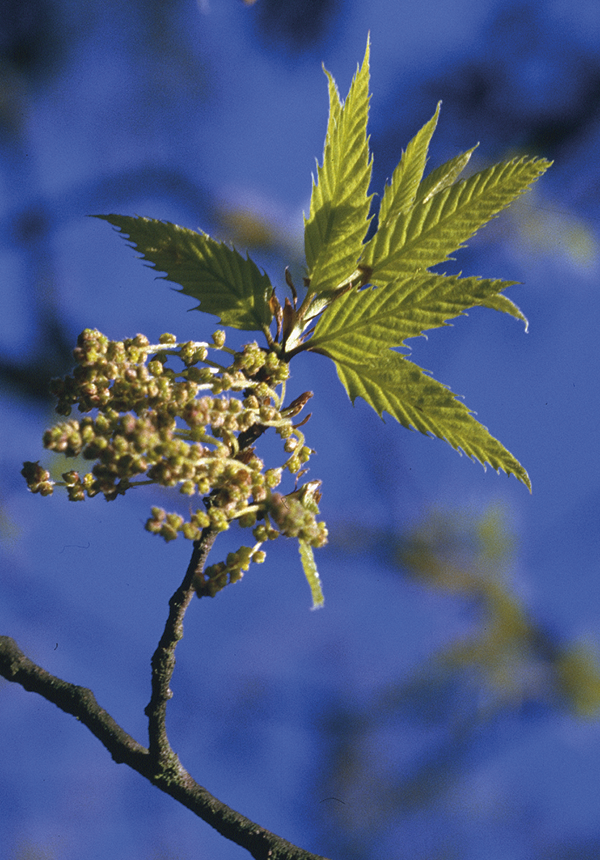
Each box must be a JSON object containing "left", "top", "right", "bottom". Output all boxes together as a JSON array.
[{"left": 379, "top": 102, "right": 441, "bottom": 229}]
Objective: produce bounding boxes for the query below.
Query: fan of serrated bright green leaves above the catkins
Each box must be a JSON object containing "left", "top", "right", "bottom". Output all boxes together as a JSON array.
[{"left": 98, "top": 37, "right": 550, "bottom": 489}]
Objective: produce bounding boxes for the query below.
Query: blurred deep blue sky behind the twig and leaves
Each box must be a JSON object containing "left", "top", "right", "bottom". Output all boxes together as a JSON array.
[{"left": 0, "top": 0, "right": 600, "bottom": 860}]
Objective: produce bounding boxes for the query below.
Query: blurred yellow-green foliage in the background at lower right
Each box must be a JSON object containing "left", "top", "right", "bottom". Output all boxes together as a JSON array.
[{"left": 398, "top": 507, "right": 600, "bottom": 716}]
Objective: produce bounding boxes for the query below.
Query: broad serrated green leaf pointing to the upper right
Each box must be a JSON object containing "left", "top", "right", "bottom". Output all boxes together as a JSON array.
[{"left": 365, "top": 158, "right": 550, "bottom": 284}]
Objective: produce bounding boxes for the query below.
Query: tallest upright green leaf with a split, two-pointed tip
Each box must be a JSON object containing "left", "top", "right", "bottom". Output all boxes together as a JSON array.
[{"left": 304, "top": 37, "right": 371, "bottom": 293}]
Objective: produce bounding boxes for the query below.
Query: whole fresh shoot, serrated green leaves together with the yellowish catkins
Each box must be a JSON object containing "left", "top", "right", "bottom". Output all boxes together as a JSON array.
[{"left": 28, "top": 42, "right": 549, "bottom": 620}]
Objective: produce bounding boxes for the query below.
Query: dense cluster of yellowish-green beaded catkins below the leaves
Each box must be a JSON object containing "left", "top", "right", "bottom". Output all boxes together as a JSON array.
[{"left": 22, "top": 329, "right": 327, "bottom": 593}]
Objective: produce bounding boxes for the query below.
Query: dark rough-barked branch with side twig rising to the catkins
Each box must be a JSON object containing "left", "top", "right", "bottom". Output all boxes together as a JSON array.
[{"left": 0, "top": 529, "right": 327, "bottom": 860}]
